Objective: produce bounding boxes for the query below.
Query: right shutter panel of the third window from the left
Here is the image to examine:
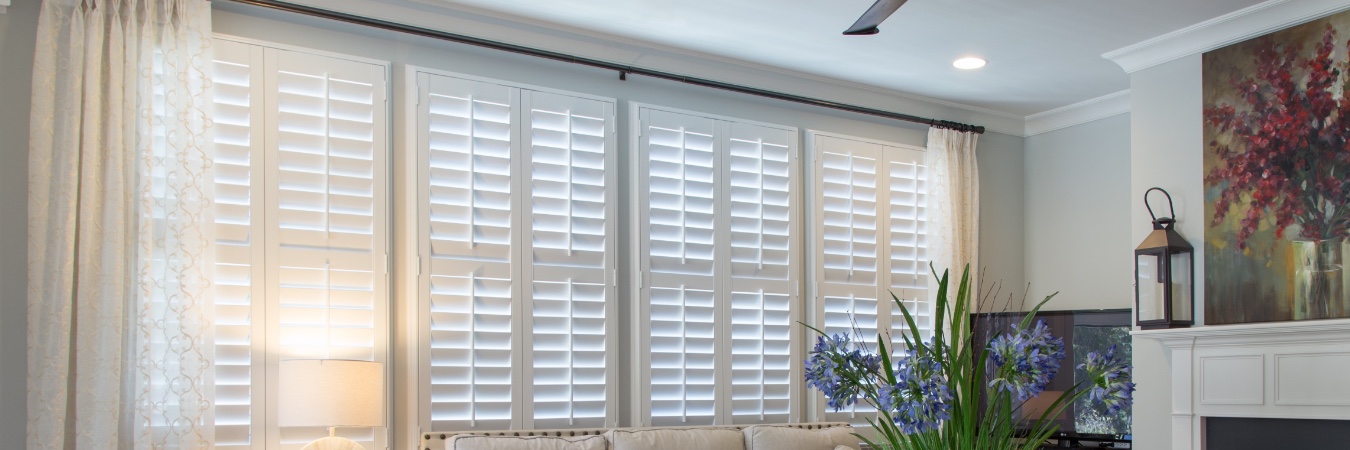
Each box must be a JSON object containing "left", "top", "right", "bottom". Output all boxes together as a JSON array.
[{"left": 724, "top": 123, "right": 801, "bottom": 424}]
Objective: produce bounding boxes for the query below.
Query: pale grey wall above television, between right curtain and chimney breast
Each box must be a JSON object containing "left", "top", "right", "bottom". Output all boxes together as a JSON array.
[{"left": 1011, "top": 114, "right": 1146, "bottom": 309}]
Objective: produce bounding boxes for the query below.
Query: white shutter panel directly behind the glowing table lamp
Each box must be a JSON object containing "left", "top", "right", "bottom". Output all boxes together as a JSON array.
[{"left": 266, "top": 49, "right": 387, "bottom": 449}]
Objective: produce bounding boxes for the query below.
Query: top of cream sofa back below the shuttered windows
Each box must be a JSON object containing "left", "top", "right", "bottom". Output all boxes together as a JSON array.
[{"left": 423, "top": 423, "right": 861, "bottom": 450}]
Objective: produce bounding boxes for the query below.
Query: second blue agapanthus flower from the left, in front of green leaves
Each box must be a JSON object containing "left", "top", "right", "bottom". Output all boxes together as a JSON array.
[{"left": 878, "top": 344, "right": 952, "bottom": 434}]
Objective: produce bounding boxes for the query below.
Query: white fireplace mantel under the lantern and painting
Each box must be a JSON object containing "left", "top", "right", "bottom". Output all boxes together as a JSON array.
[{"left": 1133, "top": 319, "right": 1350, "bottom": 450}]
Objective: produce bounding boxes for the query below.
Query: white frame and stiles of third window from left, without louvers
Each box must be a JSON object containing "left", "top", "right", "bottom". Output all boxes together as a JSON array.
[{"left": 625, "top": 101, "right": 810, "bottom": 427}]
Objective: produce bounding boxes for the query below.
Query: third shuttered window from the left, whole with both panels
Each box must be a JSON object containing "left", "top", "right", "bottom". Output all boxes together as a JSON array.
[{"left": 633, "top": 105, "right": 801, "bottom": 426}]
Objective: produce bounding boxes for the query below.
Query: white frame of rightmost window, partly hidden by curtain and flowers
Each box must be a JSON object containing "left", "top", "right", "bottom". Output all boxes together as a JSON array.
[{"left": 803, "top": 130, "right": 936, "bottom": 426}]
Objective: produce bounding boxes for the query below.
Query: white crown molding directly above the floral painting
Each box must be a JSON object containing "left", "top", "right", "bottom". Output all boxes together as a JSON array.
[{"left": 1102, "top": 0, "right": 1350, "bottom": 73}]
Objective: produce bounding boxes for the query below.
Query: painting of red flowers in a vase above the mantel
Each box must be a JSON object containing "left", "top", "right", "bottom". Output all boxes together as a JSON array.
[{"left": 1192, "top": 12, "right": 1350, "bottom": 324}]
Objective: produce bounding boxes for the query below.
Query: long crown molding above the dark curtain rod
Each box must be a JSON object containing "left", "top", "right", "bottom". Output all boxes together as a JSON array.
[{"left": 234, "top": 0, "right": 1026, "bottom": 136}]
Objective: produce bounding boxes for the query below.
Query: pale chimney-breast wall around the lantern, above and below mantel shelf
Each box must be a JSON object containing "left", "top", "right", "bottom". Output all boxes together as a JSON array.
[{"left": 1122, "top": 54, "right": 1204, "bottom": 450}]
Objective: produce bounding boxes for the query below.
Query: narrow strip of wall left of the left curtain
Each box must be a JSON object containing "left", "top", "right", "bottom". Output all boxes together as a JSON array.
[{"left": 0, "top": 1, "right": 39, "bottom": 449}]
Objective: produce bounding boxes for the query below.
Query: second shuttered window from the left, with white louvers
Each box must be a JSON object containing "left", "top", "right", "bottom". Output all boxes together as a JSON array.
[{"left": 416, "top": 72, "right": 617, "bottom": 430}]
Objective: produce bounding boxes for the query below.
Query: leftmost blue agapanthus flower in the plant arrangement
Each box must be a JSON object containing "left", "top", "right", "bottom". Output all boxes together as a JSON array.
[{"left": 806, "top": 334, "right": 882, "bottom": 411}]
